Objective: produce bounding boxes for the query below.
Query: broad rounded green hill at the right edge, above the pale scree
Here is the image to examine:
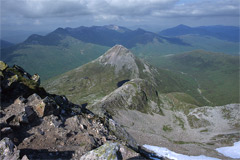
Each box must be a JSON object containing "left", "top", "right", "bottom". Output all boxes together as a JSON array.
[{"left": 148, "top": 51, "right": 239, "bottom": 105}]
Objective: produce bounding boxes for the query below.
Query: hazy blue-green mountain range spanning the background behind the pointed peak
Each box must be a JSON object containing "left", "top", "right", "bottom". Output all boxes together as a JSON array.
[{"left": 1, "top": 25, "right": 239, "bottom": 80}]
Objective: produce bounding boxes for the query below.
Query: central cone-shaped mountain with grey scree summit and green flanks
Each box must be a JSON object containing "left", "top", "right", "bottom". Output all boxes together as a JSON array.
[{"left": 44, "top": 45, "right": 206, "bottom": 105}]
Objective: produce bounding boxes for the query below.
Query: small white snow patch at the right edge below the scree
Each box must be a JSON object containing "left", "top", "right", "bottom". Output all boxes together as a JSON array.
[{"left": 216, "top": 141, "right": 240, "bottom": 158}]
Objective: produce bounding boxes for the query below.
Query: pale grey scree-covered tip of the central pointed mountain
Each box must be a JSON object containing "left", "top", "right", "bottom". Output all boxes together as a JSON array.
[{"left": 97, "top": 45, "right": 138, "bottom": 73}]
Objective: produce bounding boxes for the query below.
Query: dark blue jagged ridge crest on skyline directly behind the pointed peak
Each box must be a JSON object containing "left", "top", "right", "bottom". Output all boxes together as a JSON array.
[{"left": 24, "top": 25, "right": 189, "bottom": 48}]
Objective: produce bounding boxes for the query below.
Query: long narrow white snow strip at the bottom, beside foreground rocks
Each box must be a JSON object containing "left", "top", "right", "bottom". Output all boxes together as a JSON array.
[{"left": 143, "top": 144, "right": 220, "bottom": 160}]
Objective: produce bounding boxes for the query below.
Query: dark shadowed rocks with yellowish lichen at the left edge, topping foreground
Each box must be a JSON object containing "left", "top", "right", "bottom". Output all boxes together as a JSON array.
[{"left": 0, "top": 61, "right": 47, "bottom": 107}]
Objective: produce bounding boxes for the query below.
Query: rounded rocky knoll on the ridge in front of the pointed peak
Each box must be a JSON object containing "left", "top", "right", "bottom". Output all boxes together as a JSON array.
[{"left": 89, "top": 78, "right": 163, "bottom": 116}]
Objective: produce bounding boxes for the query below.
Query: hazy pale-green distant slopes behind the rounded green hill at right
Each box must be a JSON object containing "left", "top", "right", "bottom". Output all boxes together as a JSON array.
[{"left": 131, "top": 35, "right": 239, "bottom": 58}]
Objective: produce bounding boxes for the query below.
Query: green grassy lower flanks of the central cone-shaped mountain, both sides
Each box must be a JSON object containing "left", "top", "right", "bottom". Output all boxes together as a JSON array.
[{"left": 44, "top": 52, "right": 207, "bottom": 105}]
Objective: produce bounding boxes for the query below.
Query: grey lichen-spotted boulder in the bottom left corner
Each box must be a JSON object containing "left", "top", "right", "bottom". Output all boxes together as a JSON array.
[{"left": 0, "top": 137, "right": 19, "bottom": 160}]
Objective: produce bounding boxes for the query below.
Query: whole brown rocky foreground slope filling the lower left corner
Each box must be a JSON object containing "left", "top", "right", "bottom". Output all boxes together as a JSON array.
[{"left": 0, "top": 61, "right": 158, "bottom": 160}]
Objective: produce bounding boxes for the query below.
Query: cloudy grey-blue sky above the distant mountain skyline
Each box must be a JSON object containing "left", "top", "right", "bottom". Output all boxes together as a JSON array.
[{"left": 0, "top": 0, "right": 240, "bottom": 41}]
